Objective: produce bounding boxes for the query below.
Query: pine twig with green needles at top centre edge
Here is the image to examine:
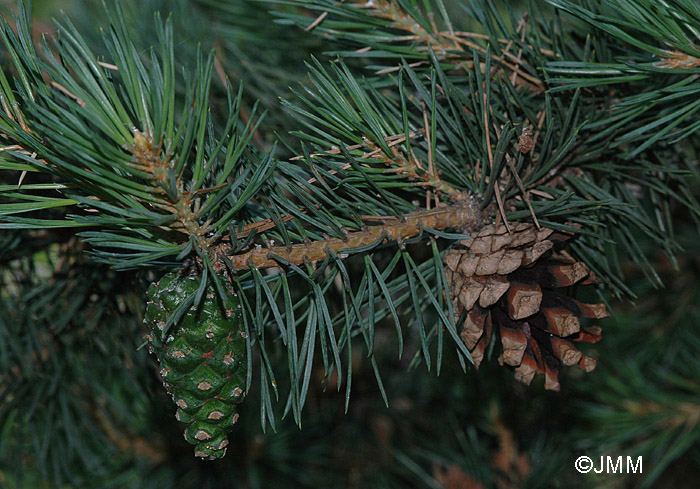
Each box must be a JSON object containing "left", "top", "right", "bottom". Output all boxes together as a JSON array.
[{"left": 275, "top": 0, "right": 554, "bottom": 92}]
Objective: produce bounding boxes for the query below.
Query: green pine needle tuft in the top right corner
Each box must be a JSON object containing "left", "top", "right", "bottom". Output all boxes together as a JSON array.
[{"left": 544, "top": 0, "right": 700, "bottom": 152}]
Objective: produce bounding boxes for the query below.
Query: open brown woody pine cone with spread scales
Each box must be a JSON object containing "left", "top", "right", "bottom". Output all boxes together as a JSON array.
[{"left": 444, "top": 223, "right": 609, "bottom": 390}]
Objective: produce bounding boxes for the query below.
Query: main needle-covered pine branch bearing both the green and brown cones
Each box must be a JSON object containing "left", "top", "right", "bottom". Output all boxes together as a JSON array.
[{"left": 0, "top": 3, "right": 694, "bottom": 442}]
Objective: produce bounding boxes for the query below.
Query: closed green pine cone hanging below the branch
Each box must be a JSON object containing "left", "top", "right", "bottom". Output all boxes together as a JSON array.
[{"left": 145, "top": 272, "right": 246, "bottom": 460}]
